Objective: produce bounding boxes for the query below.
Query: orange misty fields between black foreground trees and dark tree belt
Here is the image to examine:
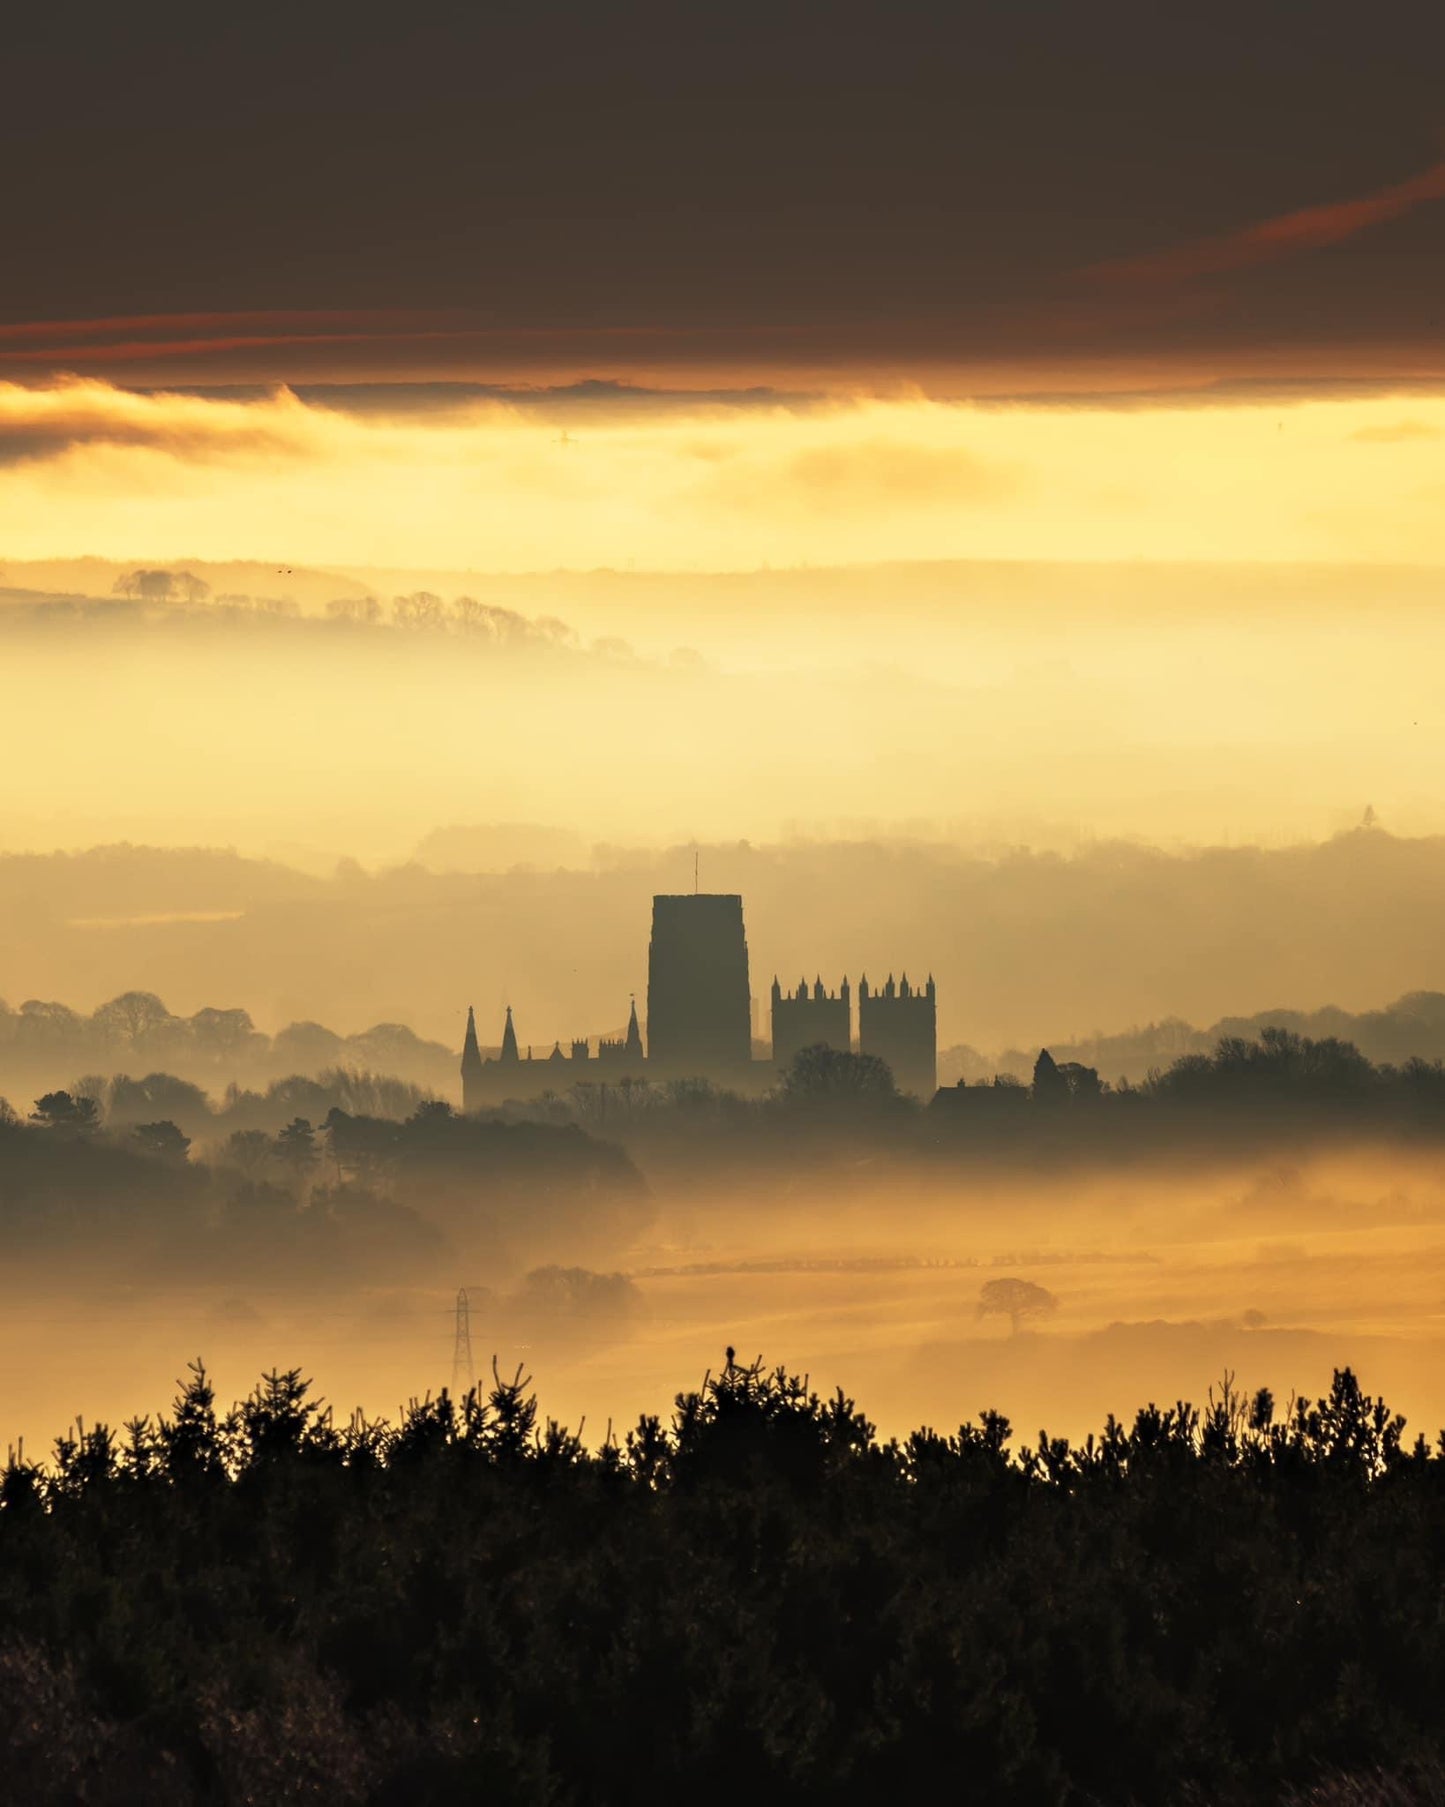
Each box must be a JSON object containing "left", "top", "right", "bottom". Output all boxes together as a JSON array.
[{"left": 0, "top": 1146, "right": 1445, "bottom": 1474}]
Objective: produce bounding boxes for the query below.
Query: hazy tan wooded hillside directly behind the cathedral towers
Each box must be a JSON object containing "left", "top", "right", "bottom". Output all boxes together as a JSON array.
[{"left": 0, "top": 824, "right": 1445, "bottom": 1052}]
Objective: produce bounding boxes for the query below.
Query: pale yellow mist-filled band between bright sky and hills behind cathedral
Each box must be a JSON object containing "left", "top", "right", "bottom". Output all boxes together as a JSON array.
[{"left": 0, "top": 564, "right": 1445, "bottom": 864}]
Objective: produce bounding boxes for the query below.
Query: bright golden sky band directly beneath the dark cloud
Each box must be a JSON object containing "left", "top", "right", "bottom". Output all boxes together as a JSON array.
[{"left": 0, "top": 381, "right": 1445, "bottom": 571}]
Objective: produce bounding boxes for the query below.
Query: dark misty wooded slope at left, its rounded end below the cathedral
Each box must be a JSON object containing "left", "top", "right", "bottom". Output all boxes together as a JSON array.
[{"left": 0, "top": 1091, "right": 650, "bottom": 1285}]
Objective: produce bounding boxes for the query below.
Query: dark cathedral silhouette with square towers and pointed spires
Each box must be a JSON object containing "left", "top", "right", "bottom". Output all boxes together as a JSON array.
[{"left": 462, "top": 893, "right": 937, "bottom": 1111}]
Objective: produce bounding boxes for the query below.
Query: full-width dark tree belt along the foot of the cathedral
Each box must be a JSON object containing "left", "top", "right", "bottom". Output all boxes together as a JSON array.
[{"left": 0, "top": 1030, "right": 1445, "bottom": 1279}]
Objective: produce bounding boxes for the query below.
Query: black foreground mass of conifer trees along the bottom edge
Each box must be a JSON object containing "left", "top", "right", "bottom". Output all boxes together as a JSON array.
[{"left": 0, "top": 1359, "right": 1445, "bottom": 1807}]
